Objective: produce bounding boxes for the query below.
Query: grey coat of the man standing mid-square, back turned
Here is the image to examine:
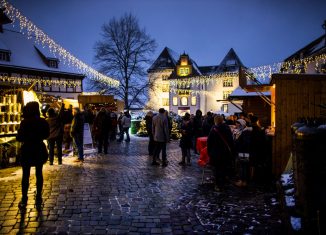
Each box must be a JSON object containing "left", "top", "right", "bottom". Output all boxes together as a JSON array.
[{"left": 152, "top": 113, "right": 169, "bottom": 142}]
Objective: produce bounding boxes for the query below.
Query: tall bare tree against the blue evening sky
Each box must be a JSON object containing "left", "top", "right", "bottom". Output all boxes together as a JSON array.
[{"left": 90, "top": 14, "right": 156, "bottom": 109}]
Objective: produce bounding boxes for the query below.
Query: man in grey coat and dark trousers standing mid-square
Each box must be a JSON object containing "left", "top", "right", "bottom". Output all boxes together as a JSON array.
[{"left": 152, "top": 108, "right": 170, "bottom": 167}]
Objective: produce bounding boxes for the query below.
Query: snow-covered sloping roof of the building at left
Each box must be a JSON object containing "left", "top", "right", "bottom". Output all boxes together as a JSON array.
[{"left": 0, "top": 28, "right": 84, "bottom": 76}]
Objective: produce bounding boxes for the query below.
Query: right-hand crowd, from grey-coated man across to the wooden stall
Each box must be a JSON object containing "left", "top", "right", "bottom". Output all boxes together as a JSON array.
[{"left": 145, "top": 108, "right": 270, "bottom": 191}]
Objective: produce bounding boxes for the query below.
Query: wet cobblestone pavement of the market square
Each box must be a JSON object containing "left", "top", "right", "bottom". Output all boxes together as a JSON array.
[{"left": 0, "top": 137, "right": 282, "bottom": 234}]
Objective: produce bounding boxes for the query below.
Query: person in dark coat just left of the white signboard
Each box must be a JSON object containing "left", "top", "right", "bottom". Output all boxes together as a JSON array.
[{"left": 70, "top": 107, "right": 84, "bottom": 162}]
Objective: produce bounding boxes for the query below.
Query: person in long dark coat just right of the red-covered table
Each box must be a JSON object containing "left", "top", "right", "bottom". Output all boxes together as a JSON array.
[{"left": 207, "top": 115, "right": 233, "bottom": 191}]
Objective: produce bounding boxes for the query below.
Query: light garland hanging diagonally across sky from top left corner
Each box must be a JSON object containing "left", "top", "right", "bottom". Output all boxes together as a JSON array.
[{"left": 1, "top": 0, "right": 120, "bottom": 87}]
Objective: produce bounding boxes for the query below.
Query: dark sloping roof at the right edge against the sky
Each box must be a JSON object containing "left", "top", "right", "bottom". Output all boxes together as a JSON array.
[{"left": 284, "top": 35, "right": 326, "bottom": 61}]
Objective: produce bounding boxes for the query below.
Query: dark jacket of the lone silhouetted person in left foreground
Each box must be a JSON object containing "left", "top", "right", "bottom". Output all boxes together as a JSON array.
[{"left": 16, "top": 117, "right": 50, "bottom": 166}]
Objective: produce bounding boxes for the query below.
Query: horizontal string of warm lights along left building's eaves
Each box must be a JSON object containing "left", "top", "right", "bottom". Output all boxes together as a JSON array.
[{"left": 0, "top": 76, "right": 81, "bottom": 87}]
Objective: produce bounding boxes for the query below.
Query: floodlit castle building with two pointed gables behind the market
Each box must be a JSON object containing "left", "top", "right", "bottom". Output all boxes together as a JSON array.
[{"left": 148, "top": 47, "right": 244, "bottom": 115}]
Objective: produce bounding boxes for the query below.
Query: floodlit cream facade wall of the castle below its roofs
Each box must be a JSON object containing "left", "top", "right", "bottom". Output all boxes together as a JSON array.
[{"left": 147, "top": 69, "right": 241, "bottom": 115}]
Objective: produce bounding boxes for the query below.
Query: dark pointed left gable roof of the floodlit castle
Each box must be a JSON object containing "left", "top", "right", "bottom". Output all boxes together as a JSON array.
[{"left": 147, "top": 47, "right": 179, "bottom": 72}]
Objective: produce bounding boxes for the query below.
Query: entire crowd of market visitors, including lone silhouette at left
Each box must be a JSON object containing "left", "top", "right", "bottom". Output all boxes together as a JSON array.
[{"left": 17, "top": 102, "right": 267, "bottom": 208}]
